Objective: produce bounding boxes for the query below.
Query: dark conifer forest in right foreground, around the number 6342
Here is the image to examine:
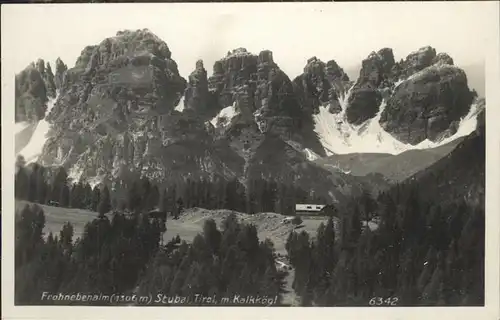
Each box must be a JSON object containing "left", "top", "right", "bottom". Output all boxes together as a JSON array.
[{"left": 286, "top": 184, "right": 485, "bottom": 306}]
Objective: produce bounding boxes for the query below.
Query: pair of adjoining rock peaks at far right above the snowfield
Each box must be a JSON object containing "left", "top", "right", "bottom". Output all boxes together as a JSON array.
[{"left": 346, "top": 47, "right": 473, "bottom": 144}]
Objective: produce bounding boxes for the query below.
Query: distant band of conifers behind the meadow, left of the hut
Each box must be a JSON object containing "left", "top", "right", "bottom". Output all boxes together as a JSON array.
[{"left": 15, "top": 158, "right": 327, "bottom": 215}]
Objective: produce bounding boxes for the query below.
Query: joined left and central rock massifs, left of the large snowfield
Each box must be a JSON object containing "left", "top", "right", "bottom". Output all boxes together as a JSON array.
[{"left": 31, "top": 30, "right": 361, "bottom": 199}]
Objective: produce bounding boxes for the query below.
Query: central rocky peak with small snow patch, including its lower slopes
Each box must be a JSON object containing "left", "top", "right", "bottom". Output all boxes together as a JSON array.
[{"left": 185, "top": 48, "right": 360, "bottom": 199}]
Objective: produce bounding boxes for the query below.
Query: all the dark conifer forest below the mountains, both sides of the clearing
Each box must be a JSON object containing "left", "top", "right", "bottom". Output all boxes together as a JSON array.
[{"left": 15, "top": 156, "right": 485, "bottom": 306}]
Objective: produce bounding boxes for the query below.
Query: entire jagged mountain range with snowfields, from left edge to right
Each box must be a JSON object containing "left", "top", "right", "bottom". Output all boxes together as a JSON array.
[{"left": 15, "top": 29, "right": 485, "bottom": 202}]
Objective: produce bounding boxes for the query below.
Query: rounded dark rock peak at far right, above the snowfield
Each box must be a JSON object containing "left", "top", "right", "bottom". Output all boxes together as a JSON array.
[{"left": 380, "top": 58, "right": 474, "bottom": 145}]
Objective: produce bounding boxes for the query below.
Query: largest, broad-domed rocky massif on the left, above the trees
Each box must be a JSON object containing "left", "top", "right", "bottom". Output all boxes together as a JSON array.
[{"left": 37, "top": 29, "right": 191, "bottom": 184}]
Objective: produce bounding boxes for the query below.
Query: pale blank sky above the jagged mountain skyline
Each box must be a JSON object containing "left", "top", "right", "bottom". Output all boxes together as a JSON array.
[{"left": 1, "top": 2, "right": 492, "bottom": 82}]
